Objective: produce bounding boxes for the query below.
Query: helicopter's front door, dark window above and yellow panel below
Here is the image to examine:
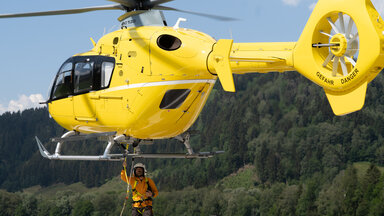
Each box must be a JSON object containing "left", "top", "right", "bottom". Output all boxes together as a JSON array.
[{"left": 73, "top": 59, "right": 97, "bottom": 121}]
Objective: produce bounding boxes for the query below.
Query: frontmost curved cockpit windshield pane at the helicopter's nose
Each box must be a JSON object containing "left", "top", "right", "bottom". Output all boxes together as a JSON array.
[{"left": 51, "top": 62, "right": 73, "bottom": 99}]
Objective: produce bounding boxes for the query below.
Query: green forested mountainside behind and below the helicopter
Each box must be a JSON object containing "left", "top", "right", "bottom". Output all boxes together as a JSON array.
[{"left": 0, "top": 72, "right": 384, "bottom": 215}]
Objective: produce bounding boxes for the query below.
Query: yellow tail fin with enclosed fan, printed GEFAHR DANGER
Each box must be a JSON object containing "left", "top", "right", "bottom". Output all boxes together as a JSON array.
[{"left": 293, "top": 0, "right": 384, "bottom": 115}]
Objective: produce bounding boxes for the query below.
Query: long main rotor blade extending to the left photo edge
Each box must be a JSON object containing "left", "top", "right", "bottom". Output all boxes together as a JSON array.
[{"left": 0, "top": 5, "right": 124, "bottom": 18}]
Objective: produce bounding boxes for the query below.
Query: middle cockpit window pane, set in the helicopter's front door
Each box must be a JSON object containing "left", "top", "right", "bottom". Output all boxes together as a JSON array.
[{"left": 74, "top": 62, "right": 94, "bottom": 94}]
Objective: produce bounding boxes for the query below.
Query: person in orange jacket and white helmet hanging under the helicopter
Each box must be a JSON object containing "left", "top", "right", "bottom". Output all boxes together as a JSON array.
[{"left": 121, "top": 161, "right": 159, "bottom": 216}]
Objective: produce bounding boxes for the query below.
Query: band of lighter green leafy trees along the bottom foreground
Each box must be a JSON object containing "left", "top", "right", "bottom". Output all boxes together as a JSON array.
[{"left": 0, "top": 162, "right": 384, "bottom": 215}]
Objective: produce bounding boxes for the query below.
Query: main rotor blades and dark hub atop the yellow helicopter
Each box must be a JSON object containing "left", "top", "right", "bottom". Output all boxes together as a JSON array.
[{"left": 0, "top": 0, "right": 235, "bottom": 21}]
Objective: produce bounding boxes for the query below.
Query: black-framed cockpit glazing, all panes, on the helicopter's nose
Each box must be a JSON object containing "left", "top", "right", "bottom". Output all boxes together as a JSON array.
[{"left": 50, "top": 56, "right": 115, "bottom": 101}]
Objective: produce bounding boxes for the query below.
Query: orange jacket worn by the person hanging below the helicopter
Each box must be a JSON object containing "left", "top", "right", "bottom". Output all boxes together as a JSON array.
[{"left": 121, "top": 170, "right": 159, "bottom": 208}]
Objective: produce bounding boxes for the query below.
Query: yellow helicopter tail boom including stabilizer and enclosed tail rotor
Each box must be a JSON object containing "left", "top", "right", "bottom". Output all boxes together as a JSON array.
[{"left": 208, "top": 0, "right": 384, "bottom": 115}]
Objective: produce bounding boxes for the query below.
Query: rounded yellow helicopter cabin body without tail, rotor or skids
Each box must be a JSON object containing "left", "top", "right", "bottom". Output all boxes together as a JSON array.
[{"left": 48, "top": 26, "right": 217, "bottom": 139}]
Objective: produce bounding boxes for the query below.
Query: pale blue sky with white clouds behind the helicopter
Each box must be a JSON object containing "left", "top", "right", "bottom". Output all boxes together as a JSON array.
[{"left": 0, "top": 0, "right": 384, "bottom": 114}]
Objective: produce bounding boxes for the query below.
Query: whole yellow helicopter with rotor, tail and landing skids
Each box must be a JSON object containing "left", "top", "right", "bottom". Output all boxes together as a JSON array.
[{"left": 0, "top": 0, "right": 384, "bottom": 161}]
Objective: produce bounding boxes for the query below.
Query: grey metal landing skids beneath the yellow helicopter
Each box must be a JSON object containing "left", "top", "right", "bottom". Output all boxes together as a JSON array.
[{"left": 35, "top": 131, "right": 224, "bottom": 161}]
